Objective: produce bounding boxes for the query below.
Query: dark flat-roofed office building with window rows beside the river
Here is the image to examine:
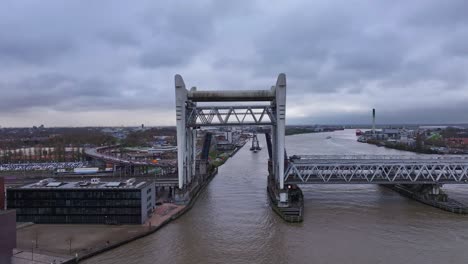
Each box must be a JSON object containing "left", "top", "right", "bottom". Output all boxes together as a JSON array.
[{"left": 7, "top": 179, "right": 156, "bottom": 224}]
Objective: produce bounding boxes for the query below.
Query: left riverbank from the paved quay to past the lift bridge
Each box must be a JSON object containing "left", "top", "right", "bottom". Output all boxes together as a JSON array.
[{"left": 17, "top": 143, "right": 241, "bottom": 263}]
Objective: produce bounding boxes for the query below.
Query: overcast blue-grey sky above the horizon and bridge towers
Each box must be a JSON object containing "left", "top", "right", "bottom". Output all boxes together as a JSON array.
[{"left": 0, "top": 0, "right": 468, "bottom": 127}]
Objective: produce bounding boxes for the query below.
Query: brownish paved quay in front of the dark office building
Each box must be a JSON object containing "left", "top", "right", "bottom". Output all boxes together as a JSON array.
[{"left": 13, "top": 203, "right": 186, "bottom": 264}]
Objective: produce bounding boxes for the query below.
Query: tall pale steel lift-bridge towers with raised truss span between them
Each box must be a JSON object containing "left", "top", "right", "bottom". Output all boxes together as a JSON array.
[{"left": 175, "top": 73, "right": 287, "bottom": 203}]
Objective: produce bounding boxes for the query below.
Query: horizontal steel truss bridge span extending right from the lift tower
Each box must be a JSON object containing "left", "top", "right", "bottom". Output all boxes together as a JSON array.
[{"left": 285, "top": 155, "right": 468, "bottom": 184}]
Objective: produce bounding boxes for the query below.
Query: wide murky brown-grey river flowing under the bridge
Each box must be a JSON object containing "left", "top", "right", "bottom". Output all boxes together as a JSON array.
[{"left": 84, "top": 130, "right": 468, "bottom": 264}]
